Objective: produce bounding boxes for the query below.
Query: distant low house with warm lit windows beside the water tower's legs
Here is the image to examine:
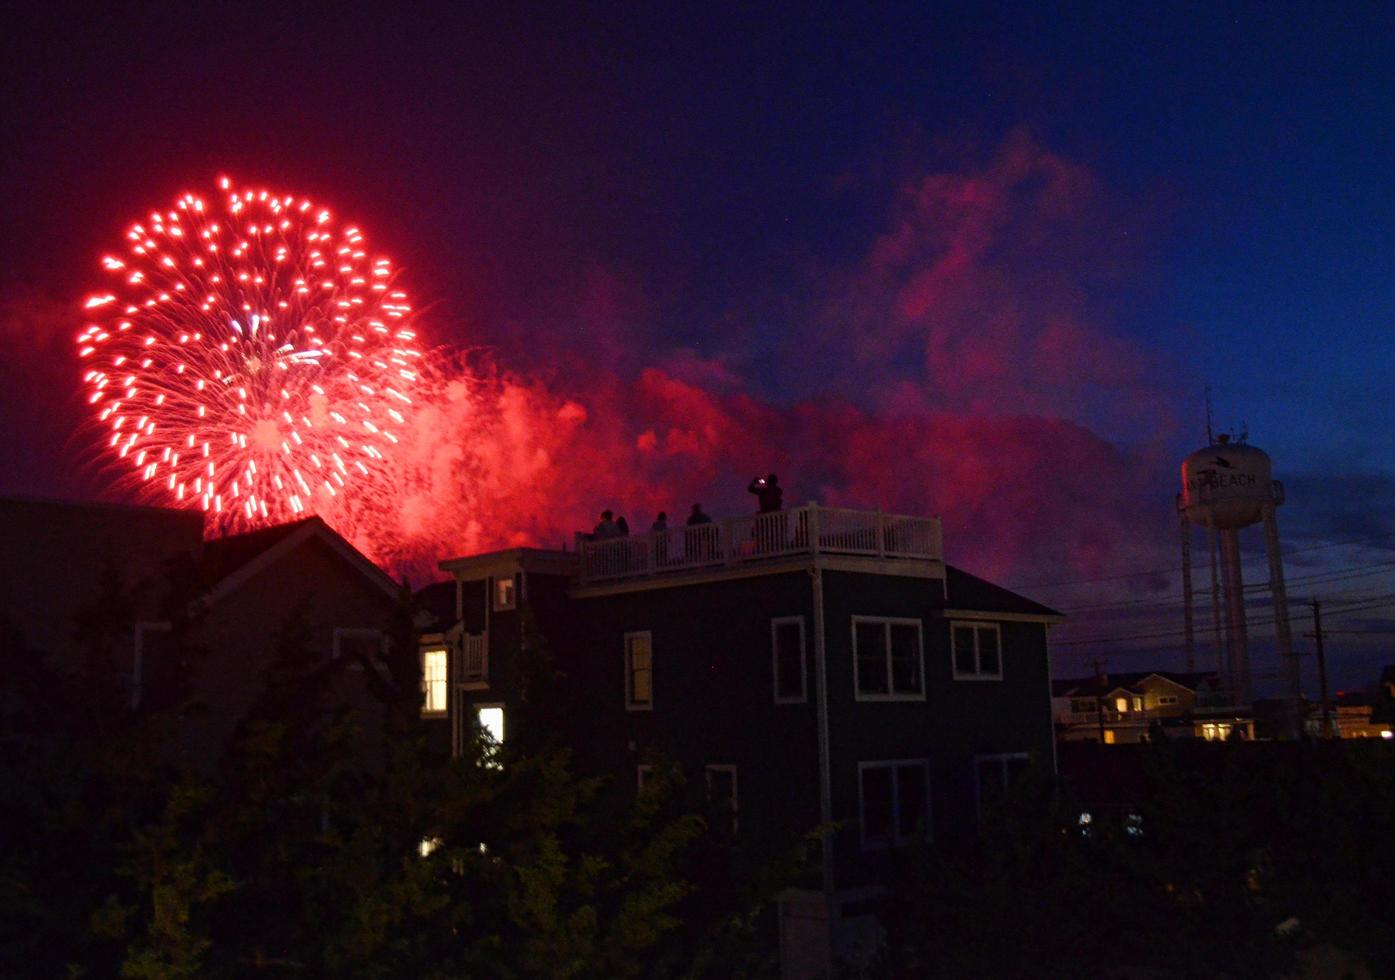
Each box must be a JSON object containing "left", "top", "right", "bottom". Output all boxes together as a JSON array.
[{"left": 1052, "top": 671, "right": 1254, "bottom": 744}]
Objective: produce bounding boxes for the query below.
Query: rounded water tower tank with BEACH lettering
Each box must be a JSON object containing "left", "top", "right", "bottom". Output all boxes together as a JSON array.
[{"left": 1182, "top": 436, "right": 1282, "bottom": 530}]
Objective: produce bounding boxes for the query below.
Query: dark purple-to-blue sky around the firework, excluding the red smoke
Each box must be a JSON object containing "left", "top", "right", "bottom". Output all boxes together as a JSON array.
[{"left": 0, "top": 3, "right": 1395, "bottom": 691}]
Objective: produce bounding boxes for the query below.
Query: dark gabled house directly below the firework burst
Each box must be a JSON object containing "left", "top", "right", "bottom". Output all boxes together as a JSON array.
[{"left": 0, "top": 499, "right": 398, "bottom": 761}]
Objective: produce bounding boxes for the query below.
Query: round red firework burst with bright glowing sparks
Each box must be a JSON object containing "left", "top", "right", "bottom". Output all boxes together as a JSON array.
[{"left": 77, "top": 177, "right": 421, "bottom": 531}]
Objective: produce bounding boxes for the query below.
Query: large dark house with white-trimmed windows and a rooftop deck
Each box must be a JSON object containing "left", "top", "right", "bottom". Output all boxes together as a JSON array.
[{"left": 421, "top": 505, "right": 1062, "bottom": 974}]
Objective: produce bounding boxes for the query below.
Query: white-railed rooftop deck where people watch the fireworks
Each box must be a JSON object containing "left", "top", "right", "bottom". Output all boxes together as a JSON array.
[{"left": 578, "top": 503, "right": 943, "bottom": 585}]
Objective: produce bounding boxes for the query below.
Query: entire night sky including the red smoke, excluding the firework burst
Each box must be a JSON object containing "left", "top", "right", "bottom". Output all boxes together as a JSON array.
[{"left": 0, "top": 3, "right": 1395, "bottom": 687}]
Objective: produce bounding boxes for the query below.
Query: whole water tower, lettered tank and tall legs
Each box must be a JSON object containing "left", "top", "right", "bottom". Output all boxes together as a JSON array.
[{"left": 1177, "top": 435, "right": 1302, "bottom": 705}]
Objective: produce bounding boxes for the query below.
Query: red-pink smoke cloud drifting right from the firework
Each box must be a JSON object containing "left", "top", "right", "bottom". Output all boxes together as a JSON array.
[{"left": 245, "top": 132, "right": 1170, "bottom": 591}]
